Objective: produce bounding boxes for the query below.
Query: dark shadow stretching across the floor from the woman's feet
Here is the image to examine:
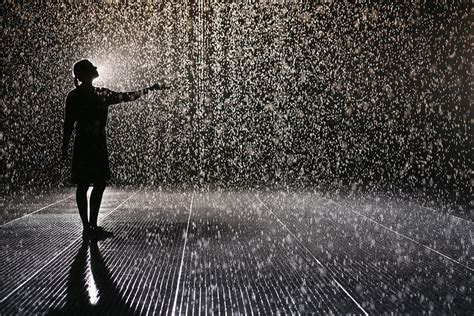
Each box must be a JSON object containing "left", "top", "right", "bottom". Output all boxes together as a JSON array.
[{"left": 48, "top": 241, "right": 136, "bottom": 315}]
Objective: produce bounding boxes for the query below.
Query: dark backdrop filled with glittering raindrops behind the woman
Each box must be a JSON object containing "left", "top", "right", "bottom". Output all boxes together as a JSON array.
[{"left": 0, "top": 1, "right": 473, "bottom": 214}]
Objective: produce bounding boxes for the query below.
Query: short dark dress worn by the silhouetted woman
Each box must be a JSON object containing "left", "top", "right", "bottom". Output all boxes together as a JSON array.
[{"left": 65, "top": 86, "right": 126, "bottom": 184}]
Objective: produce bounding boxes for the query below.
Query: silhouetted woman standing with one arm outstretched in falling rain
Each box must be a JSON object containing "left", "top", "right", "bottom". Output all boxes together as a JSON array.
[{"left": 62, "top": 59, "right": 169, "bottom": 239}]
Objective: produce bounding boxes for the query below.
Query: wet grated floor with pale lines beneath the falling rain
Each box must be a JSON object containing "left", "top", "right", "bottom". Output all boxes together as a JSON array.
[{"left": 0, "top": 189, "right": 474, "bottom": 315}]
